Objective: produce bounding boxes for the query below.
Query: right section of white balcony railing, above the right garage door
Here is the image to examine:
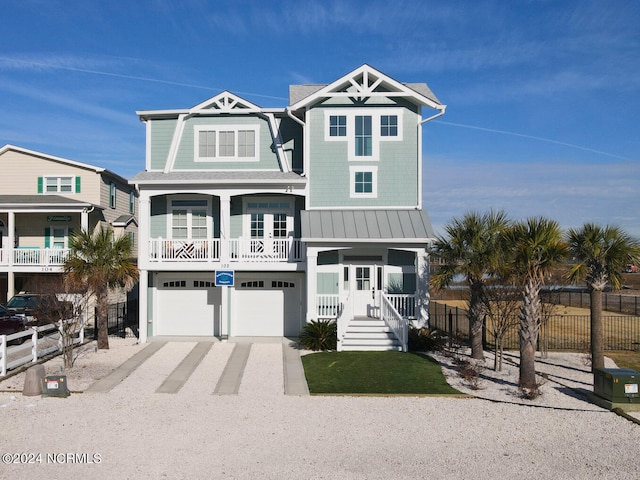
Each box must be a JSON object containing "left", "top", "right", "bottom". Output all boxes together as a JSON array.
[{"left": 229, "top": 237, "right": 304, "bottom": 263}]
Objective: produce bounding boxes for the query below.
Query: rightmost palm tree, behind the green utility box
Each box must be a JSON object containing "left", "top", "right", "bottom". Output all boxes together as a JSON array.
[{"left": 566, "top": 223, "right": 640, "bottom": 369}]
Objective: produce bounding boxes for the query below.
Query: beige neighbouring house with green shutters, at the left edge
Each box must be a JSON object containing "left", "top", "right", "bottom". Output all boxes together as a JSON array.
[{"left": 0, "top": 145, "right": 137, "bottom": 304}]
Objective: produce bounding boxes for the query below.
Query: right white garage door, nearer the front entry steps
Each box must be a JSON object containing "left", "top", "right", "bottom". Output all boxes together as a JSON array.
[{"left": 231, "top": 279, "right": 301, "bottom": 337}]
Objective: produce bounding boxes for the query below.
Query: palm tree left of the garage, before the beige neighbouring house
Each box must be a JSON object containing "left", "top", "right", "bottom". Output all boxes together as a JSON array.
[{"left": 64, "top": 226, "right": 138, "bottom": 349}]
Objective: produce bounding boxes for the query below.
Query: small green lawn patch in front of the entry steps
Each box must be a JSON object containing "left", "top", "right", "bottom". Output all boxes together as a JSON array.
[{"left": 302, "top": 352, "right": 460, "bottom": 395}]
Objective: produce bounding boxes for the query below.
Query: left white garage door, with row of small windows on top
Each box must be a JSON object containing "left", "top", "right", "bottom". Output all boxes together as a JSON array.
[{"left": 155, "top": 278, "right": 220, "bottom": 336}]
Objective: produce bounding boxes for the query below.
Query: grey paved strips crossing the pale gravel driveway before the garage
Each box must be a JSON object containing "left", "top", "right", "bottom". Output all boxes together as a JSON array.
[{"left": 86, "top": 338, "right": 309, "bottom": 396}]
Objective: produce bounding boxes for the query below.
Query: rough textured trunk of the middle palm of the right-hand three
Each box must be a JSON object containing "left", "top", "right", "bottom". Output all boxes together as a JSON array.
[{"left": 519, "top": 279, "right": 540, "bottom": 389}]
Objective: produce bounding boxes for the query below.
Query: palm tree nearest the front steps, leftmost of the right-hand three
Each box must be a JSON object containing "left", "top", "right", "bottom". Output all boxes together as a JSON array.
[{"left": 431, "top": 210, "right": 511, "bottom": 359}]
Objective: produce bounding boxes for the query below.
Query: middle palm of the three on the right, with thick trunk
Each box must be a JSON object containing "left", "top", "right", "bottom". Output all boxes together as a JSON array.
[{"left": 505, "top": 217, "right": 567, "bottom": 390}]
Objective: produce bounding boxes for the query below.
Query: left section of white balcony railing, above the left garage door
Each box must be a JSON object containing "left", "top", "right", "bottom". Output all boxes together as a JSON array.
[{"left": 149, "top": 238, "right": 220, "bottom": 262}]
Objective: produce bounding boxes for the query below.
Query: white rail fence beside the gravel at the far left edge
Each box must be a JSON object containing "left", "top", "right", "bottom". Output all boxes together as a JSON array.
[{"left": 0, "top": 324, "right": 84, "bottom": 376}]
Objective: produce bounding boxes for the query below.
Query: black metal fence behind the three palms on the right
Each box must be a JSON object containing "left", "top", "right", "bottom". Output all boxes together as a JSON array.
[{"left": 429, "top": 302, "right": 640, "bottom": 352}]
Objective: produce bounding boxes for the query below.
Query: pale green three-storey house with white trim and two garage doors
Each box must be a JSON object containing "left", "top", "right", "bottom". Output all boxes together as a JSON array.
[{"left": 130, "top": 65, "right": 445, "bottom": 350}]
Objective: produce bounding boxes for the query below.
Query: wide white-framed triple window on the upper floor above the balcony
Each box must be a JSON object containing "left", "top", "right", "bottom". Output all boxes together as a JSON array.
[{"left": 195, "top": 125, "right": 259, "bottom": 162}]
